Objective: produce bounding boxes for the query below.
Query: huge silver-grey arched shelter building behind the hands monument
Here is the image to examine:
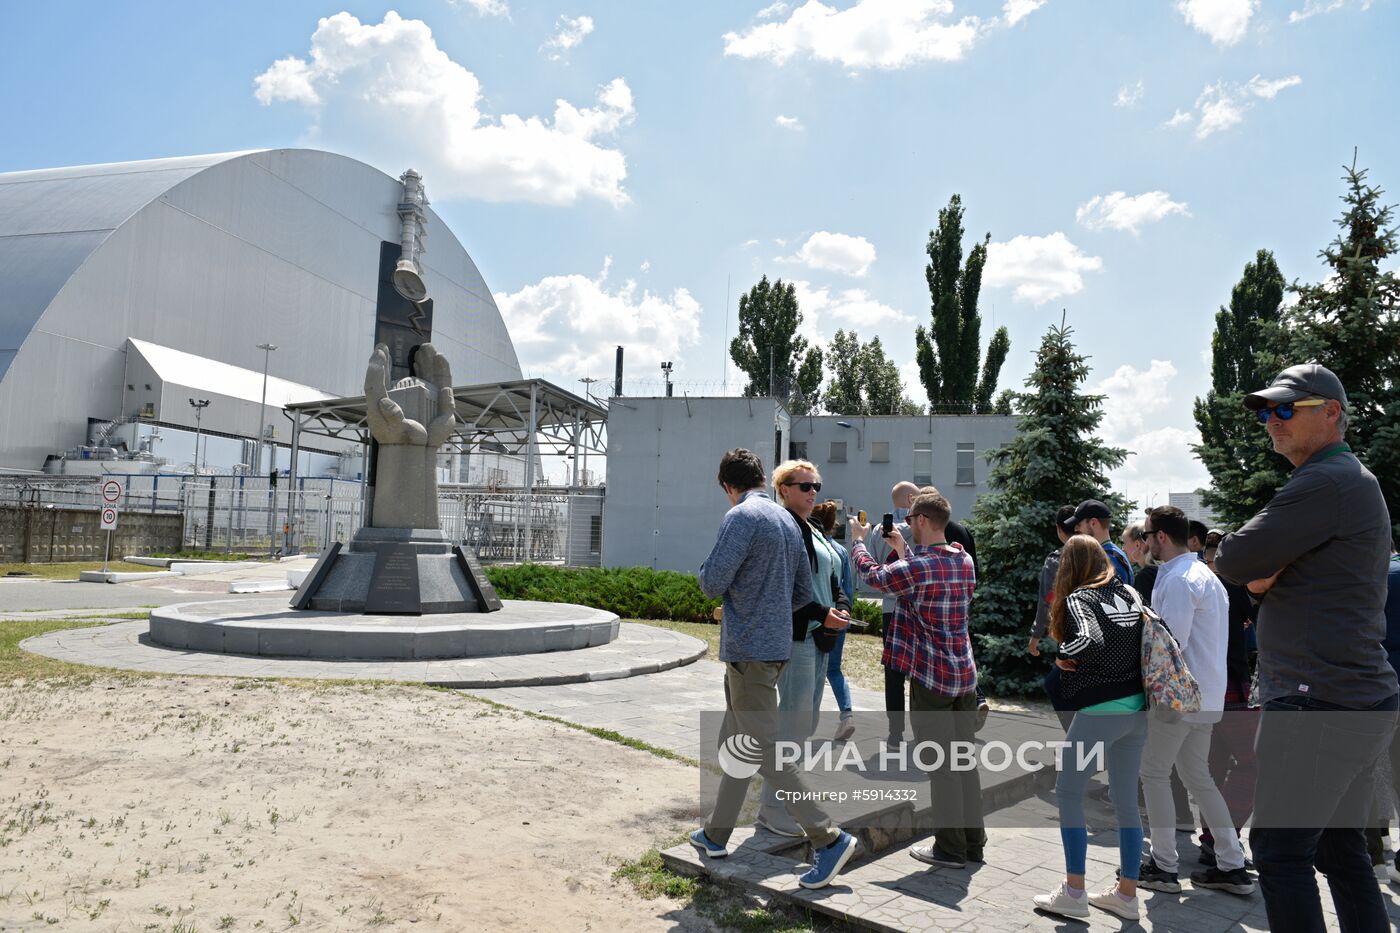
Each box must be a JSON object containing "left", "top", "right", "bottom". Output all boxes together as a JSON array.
[{"left": 0, "top": 148, "right": 521, "bottom": 469}]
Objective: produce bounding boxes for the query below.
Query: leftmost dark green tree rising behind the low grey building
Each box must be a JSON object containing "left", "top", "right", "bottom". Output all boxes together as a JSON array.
[{"left": 729, "top": 276, "right": 822, "bottom": 415}]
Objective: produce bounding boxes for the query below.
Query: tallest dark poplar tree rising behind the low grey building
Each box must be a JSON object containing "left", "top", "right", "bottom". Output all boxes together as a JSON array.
[{"left": 914, "top": 195, "right": 1011, "bottom": 413}]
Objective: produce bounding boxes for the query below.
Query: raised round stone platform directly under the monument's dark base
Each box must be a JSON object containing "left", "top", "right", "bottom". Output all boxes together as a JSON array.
[{"left": 150, "top": 595, "right": 617, "bottom": 661}]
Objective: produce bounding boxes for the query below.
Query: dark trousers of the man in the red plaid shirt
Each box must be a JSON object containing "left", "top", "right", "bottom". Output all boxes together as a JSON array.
[{"left": 909, "top": 679, "right": 987, "bottom": 859}]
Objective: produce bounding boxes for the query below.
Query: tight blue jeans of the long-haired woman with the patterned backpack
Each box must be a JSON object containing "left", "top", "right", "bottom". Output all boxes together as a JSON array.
[{"left": 1054, "top": 712, "right": 1147, "bottom": 881}]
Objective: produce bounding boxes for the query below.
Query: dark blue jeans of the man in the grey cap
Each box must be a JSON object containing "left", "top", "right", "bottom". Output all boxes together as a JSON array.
[{"left": 1249, "top": 696, "right": 1397, "bottom": 933}]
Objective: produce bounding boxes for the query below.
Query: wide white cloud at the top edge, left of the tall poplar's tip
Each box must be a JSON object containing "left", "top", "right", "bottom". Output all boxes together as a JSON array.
[{"left": 724, "top": 0, "right": 980, "bottom": 70}]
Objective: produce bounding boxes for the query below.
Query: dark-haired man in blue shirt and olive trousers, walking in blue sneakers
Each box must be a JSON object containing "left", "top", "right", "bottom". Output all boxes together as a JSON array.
[{"left": 690, "top": 447, "right": 857, "bottom": 888}]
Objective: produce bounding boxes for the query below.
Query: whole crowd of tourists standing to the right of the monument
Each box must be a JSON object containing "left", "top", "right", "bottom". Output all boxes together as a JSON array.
[{"left": 690, "top": 364, "right": 1400, "bottom": 930}]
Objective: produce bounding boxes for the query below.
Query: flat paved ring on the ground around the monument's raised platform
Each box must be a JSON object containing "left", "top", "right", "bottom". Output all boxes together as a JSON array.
[{"left": 20, "top": 621, "right": 706, "bottom": 689}]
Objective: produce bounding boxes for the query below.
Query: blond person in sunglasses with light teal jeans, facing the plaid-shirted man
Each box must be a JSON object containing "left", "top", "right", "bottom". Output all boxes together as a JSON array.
[{"left": 755, "top": 459, "right": 851, "bottom": 836}]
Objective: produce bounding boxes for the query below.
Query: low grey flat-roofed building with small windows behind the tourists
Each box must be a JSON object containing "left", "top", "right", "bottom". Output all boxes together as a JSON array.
[{"left": 602, "top": 396, "right": 1016, "bottom": 573}]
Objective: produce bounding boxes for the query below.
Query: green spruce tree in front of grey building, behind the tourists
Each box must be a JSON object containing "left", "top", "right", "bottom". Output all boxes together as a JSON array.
[{"left": 972, "top": 322, "right": 1130, "bottom": 695}]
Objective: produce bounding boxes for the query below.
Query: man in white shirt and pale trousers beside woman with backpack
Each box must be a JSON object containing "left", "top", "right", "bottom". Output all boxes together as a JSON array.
[{"left": 1138, "top": 506, "right": 1254, "bottom": 895}]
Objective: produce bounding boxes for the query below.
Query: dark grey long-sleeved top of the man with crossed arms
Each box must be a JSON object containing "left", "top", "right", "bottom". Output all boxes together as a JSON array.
[{"left": 1215, "top": 444, "right": 1396, "bottom": 709}]
